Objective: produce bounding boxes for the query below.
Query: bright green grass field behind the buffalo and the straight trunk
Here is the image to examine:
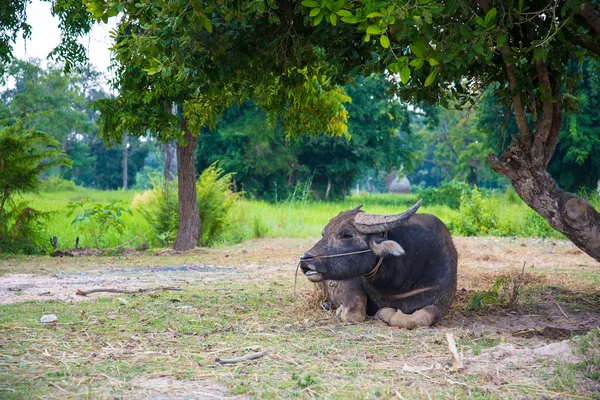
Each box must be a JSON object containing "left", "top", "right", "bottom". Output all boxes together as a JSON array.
[{"left": 17, "top": 188, "right": 548, "bottom": 248}]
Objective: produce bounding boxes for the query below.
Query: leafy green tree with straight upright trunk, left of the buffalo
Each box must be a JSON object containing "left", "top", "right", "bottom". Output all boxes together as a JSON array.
[{"left": 88, "top": 1, "right": 371, "bottom": 250}]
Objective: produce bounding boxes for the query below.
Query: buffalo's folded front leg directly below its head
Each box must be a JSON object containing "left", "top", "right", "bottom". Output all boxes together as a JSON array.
[{"left": 327, "top": 278, "right": 367, "bottom": 323}]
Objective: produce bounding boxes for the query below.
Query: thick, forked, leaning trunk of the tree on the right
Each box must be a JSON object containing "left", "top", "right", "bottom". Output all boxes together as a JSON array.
[{"left": 479, "top": 0, "right": 600, "bottom": 261}]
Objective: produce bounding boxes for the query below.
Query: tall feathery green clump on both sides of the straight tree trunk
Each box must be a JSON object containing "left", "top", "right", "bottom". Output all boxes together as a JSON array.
[{"left": 139, "top": 163, "right": 241, "bottom": 246}]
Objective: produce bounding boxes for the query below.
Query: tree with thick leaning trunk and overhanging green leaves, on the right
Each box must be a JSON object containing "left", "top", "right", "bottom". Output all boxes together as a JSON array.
[{"left": 303, "top": 0, "right": 600, "bottom": 260}]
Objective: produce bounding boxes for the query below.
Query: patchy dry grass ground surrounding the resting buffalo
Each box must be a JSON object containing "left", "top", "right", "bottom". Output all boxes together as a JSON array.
[{"left": 0, "top": 238, "right": 600, "bottom": 399}]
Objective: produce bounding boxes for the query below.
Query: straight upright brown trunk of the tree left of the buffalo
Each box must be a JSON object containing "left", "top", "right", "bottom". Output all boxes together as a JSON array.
[{"left": 173, "top": 117, "right": 200, "bottom": 251}]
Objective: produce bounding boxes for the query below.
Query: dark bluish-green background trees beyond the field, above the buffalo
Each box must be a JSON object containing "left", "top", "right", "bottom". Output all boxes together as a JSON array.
[{"left": 196, "top": 76, "right": 420, "bottom": 200}]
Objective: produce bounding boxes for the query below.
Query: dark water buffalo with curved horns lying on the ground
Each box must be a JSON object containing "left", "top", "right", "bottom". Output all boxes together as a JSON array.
[{"left": 300, "top": 200, "right": 458, "bottom": 329}]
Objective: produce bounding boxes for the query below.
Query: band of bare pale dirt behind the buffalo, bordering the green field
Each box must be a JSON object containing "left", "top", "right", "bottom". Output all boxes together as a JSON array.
[{"left": 0, "top": 237, "right": 600, "bottom": 339}]
